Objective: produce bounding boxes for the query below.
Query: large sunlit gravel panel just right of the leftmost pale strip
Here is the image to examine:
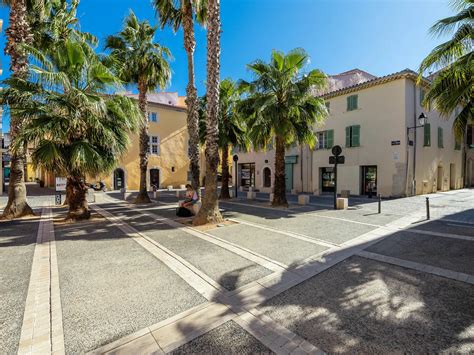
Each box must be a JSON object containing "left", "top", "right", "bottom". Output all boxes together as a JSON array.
[{"left": 55, "top": 213, "right": 206, "bottom": 354}]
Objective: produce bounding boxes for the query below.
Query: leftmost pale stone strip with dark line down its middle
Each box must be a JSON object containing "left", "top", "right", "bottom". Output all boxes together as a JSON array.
[{"left": 18, "top": 208, "right": 64, "bottom": 354}]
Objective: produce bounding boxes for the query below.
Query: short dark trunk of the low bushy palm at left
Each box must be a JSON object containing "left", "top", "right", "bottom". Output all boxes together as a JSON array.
[{"left": 66, "top": 175, "right": 91, "bottom": 221}]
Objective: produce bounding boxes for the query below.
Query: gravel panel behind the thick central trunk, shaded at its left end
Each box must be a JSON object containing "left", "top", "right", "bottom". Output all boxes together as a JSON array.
[{"left": 220, "top": 204, "right": 377, "bottom": 244}]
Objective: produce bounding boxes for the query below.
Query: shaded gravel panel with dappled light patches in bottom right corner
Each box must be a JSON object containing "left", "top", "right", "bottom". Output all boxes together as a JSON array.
[{"left": 262, "top": 257, "right": 474, "bottom": 354}]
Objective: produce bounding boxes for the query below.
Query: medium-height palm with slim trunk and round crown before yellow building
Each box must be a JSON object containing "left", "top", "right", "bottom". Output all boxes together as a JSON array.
[{"left": 106, "top": 11, "right": 171, "bottom": 203}]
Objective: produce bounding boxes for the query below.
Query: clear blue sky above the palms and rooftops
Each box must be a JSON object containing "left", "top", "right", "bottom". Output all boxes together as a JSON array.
[{"left": 0, "top": 0, "right": 452, "bottom": 131}]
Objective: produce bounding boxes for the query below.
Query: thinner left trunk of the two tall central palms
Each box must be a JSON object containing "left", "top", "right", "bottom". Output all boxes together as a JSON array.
[{"left": 183, "top": 1, "right": 201, "bottom": 195}]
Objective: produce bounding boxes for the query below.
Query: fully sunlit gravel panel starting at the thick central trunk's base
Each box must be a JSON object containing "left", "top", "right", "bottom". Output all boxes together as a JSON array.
[{"left": 208, "top": 224, "right": 327, "bottom": 265}]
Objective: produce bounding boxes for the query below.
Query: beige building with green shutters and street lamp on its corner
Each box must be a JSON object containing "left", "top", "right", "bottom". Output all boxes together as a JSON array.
[{"left": 237, "top": 69, "right": 464, "bottom": 197}]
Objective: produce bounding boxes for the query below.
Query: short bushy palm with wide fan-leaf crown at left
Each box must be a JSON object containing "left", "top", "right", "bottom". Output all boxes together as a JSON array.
[{"left": 1, "top": 39, "right": 141, "bottom": 220}]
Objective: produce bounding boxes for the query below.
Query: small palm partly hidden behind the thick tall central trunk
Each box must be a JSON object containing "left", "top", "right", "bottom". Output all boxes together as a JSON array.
[{"left": 199, "top": 79, "right": 248, "bottom": 200}]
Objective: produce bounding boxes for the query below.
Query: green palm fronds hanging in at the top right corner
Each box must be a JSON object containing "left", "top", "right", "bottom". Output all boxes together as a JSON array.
[{"left": 418, "top": 0, "right": 474, "bottom": 138}]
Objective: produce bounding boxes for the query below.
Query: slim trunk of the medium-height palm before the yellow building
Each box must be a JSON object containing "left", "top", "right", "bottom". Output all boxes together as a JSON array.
[{"left": 134, "top": 80, "right": 151, "bottom": 204}]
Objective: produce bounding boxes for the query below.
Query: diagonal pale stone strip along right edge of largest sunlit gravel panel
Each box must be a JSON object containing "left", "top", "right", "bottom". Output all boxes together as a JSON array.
[{"left": 93, "top": 206, "right": 225, "bottom": 300}]
